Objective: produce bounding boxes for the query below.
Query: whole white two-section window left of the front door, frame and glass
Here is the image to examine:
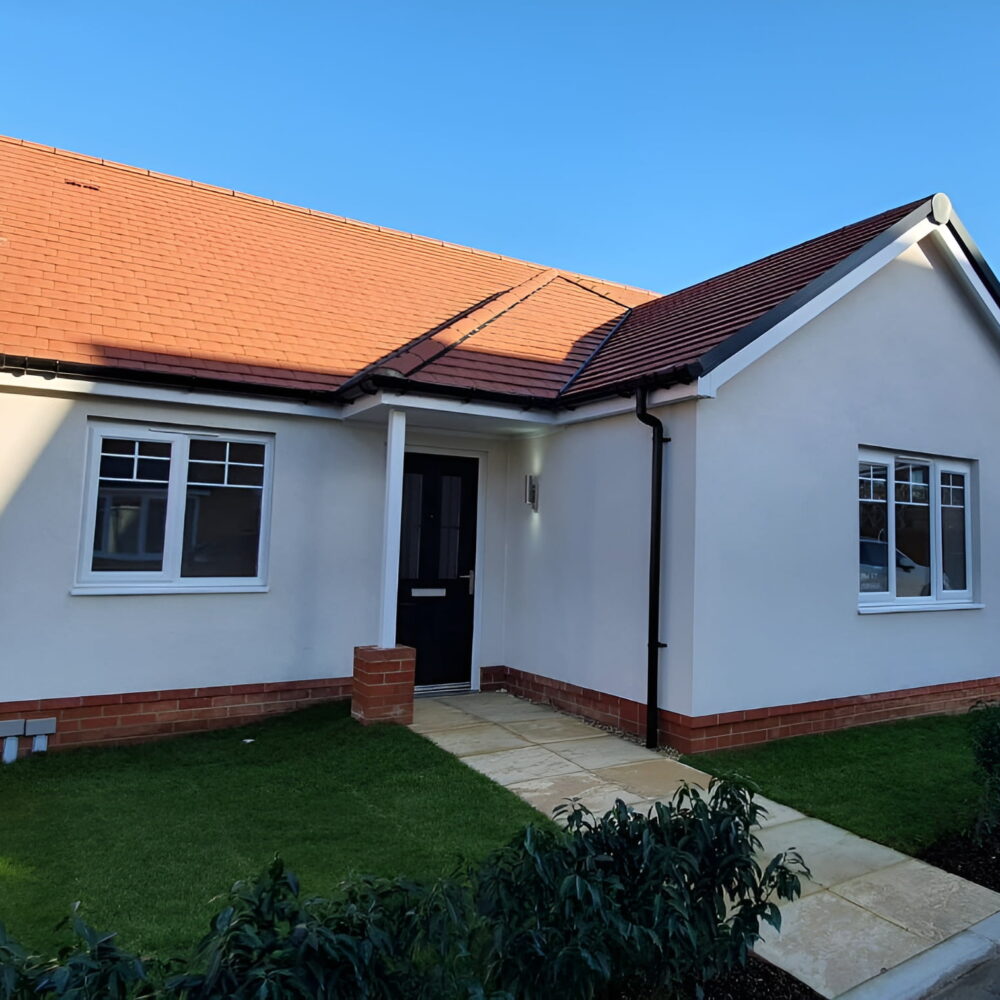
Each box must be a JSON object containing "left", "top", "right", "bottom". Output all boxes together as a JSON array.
[{"left": 73, "top": 422, "right": 273, "bottom": 594}]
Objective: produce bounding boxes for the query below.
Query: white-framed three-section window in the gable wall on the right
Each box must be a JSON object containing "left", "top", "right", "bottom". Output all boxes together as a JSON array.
[{"left": 858, "top": 449, "right": 974, "bottom": 610}]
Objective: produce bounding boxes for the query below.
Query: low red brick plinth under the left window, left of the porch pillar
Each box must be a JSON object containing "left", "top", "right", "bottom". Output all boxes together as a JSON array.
[{"left": 0, "top": 677, "right": 351, "bottom": 753}]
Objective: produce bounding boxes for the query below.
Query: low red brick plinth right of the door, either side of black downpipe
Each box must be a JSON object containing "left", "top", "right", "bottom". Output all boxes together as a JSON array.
[{"left": 481, "top": 666, "right": 1000, "bottom": 753}]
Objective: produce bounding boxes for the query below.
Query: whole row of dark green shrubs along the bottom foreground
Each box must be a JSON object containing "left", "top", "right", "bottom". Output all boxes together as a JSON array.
[{"left": 0, "top": 780, "right": 808, "bottom": 1000}]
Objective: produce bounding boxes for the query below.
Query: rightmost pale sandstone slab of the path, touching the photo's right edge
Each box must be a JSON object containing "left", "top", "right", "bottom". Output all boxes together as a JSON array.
[{"left": 833, "top": 860, "right": 1000, "bottom": 942}]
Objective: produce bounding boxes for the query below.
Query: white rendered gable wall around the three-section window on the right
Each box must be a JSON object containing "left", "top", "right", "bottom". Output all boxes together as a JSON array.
[{"left": 693, "top": 235, "right": 1000, "bottom": 715}]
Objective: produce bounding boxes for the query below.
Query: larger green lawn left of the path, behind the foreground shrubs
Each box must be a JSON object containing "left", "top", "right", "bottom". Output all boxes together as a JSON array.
[{"left": 0, "top": 704, "right": 545, "bottom": 955}]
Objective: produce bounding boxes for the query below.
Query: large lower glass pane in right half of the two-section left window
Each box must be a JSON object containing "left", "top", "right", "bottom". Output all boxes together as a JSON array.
[{"left": 181, "top": 485, "right": 263, "bottom": 577}]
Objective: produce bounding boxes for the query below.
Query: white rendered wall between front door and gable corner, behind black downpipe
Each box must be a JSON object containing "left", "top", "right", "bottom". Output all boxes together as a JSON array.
[{"left": 496, "top": 404, "right": 694, "bottom": 713}]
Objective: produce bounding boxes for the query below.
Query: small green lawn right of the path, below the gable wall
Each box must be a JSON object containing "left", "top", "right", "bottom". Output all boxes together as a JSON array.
[{"left": 684, "top": 715, "right": 979, "bottom": 854}]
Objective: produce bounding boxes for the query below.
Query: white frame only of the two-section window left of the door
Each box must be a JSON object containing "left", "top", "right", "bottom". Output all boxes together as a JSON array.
[{"left": 70, "top": 421, "right": 274, "bottom": 595}]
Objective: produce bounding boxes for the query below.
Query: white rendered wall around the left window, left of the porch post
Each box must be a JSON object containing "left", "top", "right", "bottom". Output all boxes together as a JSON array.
[{"left": 0, "top": 382, "right": 385, "bottom": 702}]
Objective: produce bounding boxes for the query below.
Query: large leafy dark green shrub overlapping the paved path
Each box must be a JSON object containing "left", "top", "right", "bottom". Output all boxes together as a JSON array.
[{"left": 474, "top": 780, "right": 808, "bottom": 1000}]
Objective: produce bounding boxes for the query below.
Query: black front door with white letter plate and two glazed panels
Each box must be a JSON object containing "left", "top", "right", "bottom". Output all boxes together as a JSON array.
[{"left": 396, "top": 452, "right": 479, "bottom": 684}]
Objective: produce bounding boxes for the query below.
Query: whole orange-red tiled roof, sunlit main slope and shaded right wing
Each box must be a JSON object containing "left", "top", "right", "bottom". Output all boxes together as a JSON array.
[{"left": 0, "top": 137, "right": 936, "bottom": 402}]
